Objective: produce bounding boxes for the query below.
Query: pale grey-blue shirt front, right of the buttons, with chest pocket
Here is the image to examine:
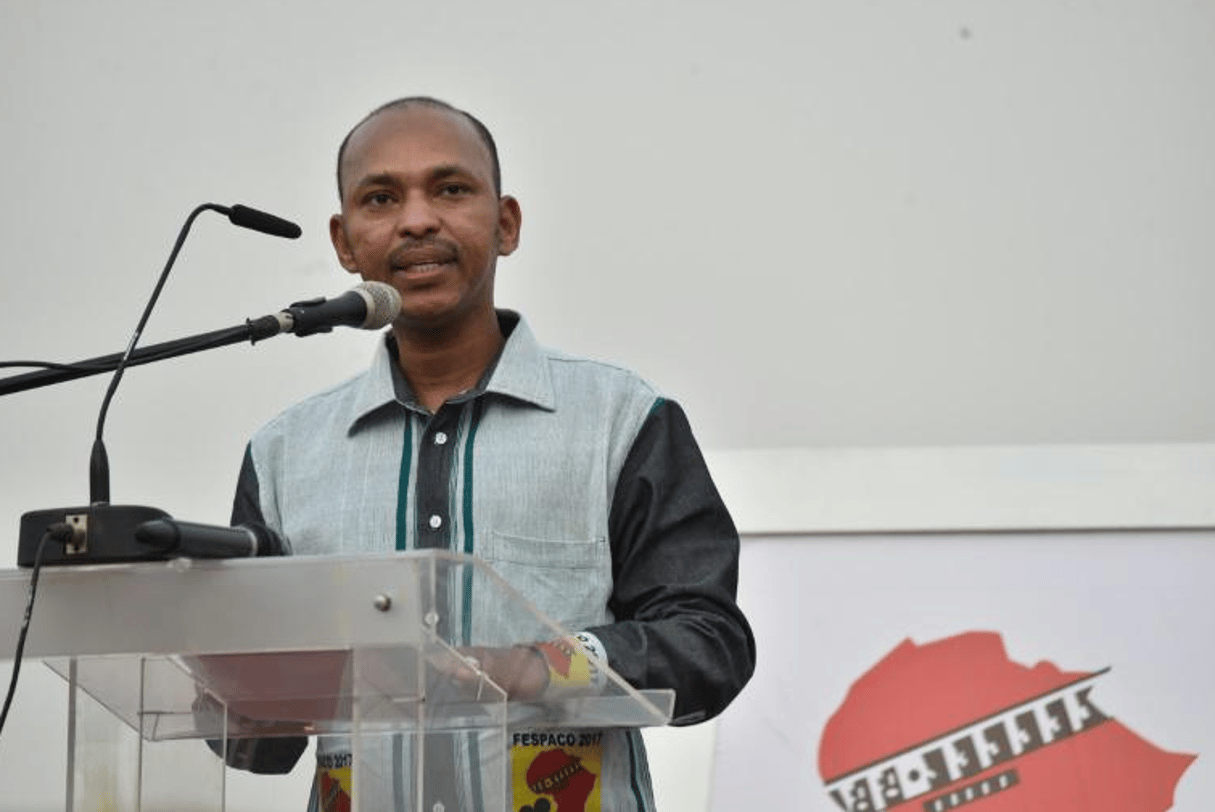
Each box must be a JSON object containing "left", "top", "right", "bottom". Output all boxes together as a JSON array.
[{"left": 473, "top": 354, "right": 657, "bottom": 631}]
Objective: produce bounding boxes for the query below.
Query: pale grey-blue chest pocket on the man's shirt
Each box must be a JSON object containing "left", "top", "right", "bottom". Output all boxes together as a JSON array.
[{"left": 476, "top": 531, "right": 611, "bottom": 642}]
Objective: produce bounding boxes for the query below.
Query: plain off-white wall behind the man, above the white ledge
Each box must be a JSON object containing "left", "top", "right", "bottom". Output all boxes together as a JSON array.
[{"left": 0, "top": 0, "right": 1215, "bottom": 808}]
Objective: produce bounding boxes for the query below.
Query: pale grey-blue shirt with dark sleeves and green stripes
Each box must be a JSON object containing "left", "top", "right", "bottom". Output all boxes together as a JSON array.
[{"left": 233, "top": 311, "right": 755, "bottom": 811}]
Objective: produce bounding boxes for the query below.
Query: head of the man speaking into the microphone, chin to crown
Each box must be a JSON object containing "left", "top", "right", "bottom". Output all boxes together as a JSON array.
[{"left": 329, "top": 105, "right": 520, "bottom": 331}]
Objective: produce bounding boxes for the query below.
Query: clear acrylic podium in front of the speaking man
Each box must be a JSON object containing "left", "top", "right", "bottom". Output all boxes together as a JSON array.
[{"left": 0, "top": 552, "right": 673, "bottom": 812}]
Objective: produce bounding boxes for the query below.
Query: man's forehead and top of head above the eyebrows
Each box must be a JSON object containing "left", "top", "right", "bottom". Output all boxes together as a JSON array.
[{"left": 343, "top": 102, "right": 492, "bottom": 182}]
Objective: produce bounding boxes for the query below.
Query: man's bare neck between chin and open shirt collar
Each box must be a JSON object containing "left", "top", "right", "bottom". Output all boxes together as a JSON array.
[{"left": 392, "top": 310, "right": 505, "bottom": 412}]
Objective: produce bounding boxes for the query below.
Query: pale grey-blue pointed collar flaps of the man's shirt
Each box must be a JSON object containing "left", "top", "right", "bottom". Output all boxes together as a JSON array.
[{"left": 350, "top": 310, "right": 556, "bottom": 432}]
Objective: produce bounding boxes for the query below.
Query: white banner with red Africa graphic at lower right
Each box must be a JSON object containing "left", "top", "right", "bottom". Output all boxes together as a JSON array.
[{"left": 713, "top": 530, "right": 1215, "bottom": 812}]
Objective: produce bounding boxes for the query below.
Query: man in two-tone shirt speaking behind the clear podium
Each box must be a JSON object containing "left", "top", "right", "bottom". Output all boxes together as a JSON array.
[{"left": 218, "top": 97, "right": 755, "bottom": 812}]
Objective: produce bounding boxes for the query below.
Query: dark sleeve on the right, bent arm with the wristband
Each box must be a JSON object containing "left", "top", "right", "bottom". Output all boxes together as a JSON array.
[{"left": 587, "top": 401, "right": 756, "bottom": 724}]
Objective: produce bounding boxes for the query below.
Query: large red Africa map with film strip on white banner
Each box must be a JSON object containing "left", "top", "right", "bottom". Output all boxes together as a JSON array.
[{"left": 819, "top": 632, "right": 1196, "bottom": 812}]
